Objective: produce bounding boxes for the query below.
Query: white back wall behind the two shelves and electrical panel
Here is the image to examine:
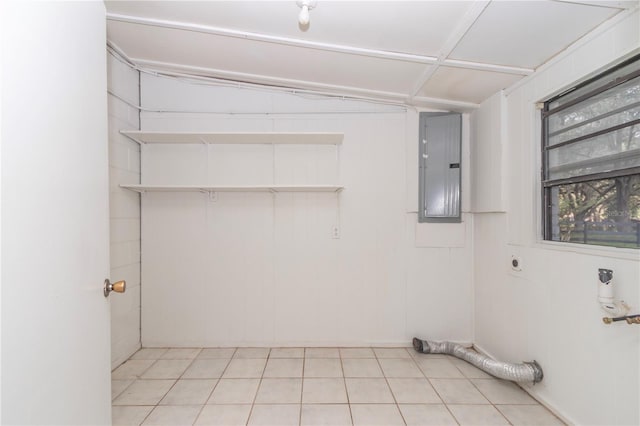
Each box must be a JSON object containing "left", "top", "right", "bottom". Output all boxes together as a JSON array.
[{"left": 135, "top": 75, "right": 472, "bottom": 346}]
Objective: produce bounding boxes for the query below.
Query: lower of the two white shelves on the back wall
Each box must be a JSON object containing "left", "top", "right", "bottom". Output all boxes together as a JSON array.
[{"left": 120, "top": 184, "right": 344, "bottom": 193}]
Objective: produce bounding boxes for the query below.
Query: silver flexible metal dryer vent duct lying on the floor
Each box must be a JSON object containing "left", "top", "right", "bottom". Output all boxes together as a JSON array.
[{"left": 413, "top": 337, "right": 543, "bottom": 383}]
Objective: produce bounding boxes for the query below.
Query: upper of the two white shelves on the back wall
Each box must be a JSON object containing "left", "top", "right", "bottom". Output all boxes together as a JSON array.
[{"left": 120, "top": 130, "right": 344, "bottom": 145}]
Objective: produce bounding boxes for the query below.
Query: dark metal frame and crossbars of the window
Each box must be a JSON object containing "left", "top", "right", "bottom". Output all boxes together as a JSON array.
[{"left": 538, "top": 54, "right": 640, "bottom": 250}]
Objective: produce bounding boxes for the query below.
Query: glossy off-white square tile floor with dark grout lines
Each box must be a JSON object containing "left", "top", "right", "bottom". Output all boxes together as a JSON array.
[{"left": 112, "top": 348, "right": 563, "bottom": 426}]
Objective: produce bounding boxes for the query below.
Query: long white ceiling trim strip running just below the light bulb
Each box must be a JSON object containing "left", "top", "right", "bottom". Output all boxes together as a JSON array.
[{"left": 107, "top": 13, "right": 437, "bottom": 64}]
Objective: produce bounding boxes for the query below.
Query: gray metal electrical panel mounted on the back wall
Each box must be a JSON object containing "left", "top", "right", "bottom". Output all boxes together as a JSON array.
[{"left": 418, "top": 112, "right": 462, "bottom": 222}]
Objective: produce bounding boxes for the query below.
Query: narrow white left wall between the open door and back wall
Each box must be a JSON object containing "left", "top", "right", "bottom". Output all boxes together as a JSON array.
[{"left": 107, "top": 54, "right": 140, "bottom": 368}]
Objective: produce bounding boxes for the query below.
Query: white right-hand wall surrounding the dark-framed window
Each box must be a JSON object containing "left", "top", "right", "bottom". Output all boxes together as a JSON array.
[{"left": 473, "top": 11, "right": 640, "bottom": 425}]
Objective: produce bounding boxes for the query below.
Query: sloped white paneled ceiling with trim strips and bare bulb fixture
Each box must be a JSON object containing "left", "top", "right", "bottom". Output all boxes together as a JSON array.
[{"left": 105, "top": 0, "right": 639, "bottom": 109}]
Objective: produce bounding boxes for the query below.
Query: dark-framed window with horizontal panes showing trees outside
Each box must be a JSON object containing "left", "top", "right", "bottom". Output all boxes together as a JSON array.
[{"left": 542, "top": 57, "right": 640, "bottom": 248}]
